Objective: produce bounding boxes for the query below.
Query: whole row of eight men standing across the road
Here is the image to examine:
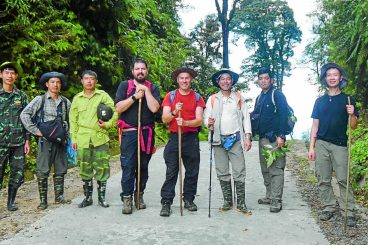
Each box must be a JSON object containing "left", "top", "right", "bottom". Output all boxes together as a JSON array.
[{"left": 0, "top": 59, "right": 358, "bottom": 226}]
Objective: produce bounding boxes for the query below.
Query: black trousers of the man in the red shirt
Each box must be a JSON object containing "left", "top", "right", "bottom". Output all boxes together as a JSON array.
[{"left": 161, "top": 132, "right": 200, "bottom": 204}]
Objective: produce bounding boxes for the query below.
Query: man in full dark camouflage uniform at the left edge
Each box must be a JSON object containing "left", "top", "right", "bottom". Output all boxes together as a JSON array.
[{"left": 0, "top": 62, "right": 30, "bottom": 211}]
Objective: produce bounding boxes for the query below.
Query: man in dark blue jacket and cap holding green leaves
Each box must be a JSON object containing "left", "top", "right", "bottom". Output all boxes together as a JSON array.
[{"left": 251, "top": 67, "right": 288, "bottom": 213}]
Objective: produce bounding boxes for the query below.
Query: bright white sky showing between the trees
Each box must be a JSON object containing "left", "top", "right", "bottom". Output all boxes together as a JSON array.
[{"left": 179, "top": 0, "right": 318, "bottom": 138}]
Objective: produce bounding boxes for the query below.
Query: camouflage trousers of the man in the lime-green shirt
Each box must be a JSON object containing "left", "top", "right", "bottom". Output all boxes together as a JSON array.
[{"left": 77, "top": 144, "right": 110, "bottom": 181}]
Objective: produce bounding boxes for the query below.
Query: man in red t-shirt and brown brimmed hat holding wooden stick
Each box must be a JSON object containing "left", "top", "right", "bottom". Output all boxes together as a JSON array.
[{"left": 160, "top": 68, "right": 206, "bottom": 217}]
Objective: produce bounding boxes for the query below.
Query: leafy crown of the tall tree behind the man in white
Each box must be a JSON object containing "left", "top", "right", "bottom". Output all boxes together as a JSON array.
[{"left": 232, "top": 0, "right": 302, "bottom": 88}]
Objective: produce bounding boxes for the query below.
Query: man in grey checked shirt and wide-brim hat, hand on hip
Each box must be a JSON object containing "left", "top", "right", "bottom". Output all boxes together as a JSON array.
[{"left": 21, "top": 71, "right": 71, "bottom": 210}]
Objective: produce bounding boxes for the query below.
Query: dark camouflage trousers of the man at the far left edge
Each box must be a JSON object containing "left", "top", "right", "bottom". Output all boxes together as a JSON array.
[{"left": 0, "top": 145, "right": 25, "bottom": 189}]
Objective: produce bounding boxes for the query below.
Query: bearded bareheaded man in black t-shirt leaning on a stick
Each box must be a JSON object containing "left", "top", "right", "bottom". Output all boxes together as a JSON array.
[{"left": 115, "top": 59, "right": 160, "bottom": 214}]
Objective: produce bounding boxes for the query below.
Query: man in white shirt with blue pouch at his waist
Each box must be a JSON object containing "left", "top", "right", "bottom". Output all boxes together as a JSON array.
[{"left": 204, "top": 68, "right": 252, "bottom": 213}]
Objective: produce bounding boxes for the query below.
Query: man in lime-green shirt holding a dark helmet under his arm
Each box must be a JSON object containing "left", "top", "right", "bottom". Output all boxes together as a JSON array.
[{"left": 69, "top": 70, "right": 118, "bottom": 208}]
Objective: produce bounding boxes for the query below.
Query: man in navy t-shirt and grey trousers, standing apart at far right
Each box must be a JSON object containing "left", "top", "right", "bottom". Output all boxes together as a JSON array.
[{"left": 308, "top": 63, "right": 359, "bottom": 226}]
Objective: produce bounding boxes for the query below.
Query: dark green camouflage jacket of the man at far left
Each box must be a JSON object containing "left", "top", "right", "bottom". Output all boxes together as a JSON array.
[{"left": 0, "top": 85, "right": 30, "bottom": 147}]
